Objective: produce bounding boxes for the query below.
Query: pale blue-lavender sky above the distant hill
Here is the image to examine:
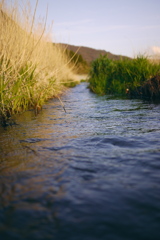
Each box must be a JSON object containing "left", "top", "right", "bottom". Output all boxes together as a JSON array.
[{"left": 21, "top": 0, "right": 160, "bottom": 57}]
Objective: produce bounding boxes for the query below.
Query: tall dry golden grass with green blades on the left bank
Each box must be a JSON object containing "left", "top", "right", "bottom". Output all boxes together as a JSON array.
[{"left": 0, "top": 0, "right": 74, "bottom": 124}]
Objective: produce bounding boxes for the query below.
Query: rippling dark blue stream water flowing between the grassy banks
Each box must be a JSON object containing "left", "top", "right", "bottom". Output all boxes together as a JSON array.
[{"left": 0, "top": 83, "right": 160, "bottom": 240}]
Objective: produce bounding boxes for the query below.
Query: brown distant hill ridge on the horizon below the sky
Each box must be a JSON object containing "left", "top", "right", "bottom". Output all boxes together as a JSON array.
[{"left": 60, "top": 43, "right": 129, "bottom": 63}]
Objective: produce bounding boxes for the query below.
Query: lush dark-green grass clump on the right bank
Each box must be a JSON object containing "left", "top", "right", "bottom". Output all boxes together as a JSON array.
[{"left": 89, "top": 55, "right": 160, "bottom": 96}]
